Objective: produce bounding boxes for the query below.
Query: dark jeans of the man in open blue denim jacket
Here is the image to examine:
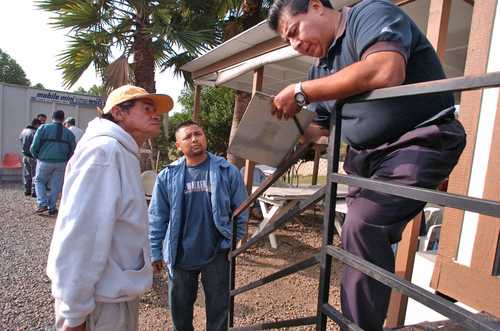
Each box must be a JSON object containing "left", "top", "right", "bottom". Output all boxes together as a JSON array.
[{"left": 168, "top": 251, "right": 229, "bottom": 331}]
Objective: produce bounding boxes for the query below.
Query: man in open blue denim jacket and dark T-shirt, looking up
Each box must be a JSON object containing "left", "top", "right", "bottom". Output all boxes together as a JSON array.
[{"left": 149, "top": 121, "right": 248, "bottom": 331}]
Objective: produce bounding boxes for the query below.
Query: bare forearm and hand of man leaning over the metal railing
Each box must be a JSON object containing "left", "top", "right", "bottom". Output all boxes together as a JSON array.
[{"left": 274, "top": 51, "right": 406, "bottom": 118}]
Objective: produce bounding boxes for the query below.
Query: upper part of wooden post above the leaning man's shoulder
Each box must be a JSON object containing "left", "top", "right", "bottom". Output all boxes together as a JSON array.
[{"left": 427, "top": 0, "right": 451, "bottom": 61}]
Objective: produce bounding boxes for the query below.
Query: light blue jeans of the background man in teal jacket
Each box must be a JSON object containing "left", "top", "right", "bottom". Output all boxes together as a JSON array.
[{"left": 35, "top": 160, "right": 66, "bottom": 209}]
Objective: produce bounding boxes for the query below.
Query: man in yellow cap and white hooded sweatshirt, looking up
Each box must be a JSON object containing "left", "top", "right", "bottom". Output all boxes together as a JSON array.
[{"left": 47, "top": 85, "right": 173, "bottom": 330}]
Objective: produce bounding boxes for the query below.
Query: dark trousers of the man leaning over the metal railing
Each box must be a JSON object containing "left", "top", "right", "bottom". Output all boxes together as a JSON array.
[{"left": 341, "top": 119, "right": 465, "bottom": 330}]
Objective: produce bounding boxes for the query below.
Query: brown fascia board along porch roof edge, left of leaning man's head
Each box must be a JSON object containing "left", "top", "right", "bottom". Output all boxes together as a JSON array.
[{"left": 192, "top": 37, "right": 288, "bottom": 79}]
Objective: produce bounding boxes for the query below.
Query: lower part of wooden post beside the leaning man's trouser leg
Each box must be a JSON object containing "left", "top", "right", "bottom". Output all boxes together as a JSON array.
[{"left": 385, "top": 212, "right": 424, "bottom": 328}]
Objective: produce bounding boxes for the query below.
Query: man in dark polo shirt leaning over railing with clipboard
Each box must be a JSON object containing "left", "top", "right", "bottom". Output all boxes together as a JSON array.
[{"left": 269, "top": 0, "right": 465, "bottom": 330}]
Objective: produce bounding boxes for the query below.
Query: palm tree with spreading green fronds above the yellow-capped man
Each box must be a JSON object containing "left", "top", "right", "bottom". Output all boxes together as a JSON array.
[{"left": 37, "top": 0, "right": 226, "bottom": 92}]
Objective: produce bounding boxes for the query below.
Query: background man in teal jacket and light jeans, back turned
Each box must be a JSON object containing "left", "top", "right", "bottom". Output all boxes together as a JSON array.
[{"left": 30, "top": 110, "right": 76, "bottom": 216}]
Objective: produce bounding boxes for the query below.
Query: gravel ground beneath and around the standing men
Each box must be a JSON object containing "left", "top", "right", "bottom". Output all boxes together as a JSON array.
[{"left": 0, "top": 183, "right": 339, "bottom": 330}]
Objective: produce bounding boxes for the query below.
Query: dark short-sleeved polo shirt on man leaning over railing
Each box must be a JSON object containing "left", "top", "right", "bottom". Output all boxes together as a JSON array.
[{"left": 309, "top": 0, "right": 454, "bottom": 149}]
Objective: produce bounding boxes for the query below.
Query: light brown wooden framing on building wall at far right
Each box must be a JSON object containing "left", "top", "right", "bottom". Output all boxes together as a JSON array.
[{"left": 431, "top": 0, "right": 500, "bottom": 316}]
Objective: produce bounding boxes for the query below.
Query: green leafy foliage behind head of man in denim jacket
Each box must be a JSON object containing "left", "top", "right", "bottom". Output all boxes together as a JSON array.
[{"left": 157, "top": 87, "right": 234, "bottom": 167}]
